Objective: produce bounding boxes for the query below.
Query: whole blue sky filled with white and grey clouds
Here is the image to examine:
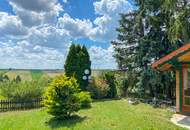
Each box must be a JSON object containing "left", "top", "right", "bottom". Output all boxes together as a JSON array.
[{"left": 0, "top": 0, "right": 133, "bottom": 69}]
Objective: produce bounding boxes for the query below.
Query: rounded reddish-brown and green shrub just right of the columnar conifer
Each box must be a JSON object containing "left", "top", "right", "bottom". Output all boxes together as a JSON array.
[{"left": 87, "top": 77, "right": 109, "bottom": 99}]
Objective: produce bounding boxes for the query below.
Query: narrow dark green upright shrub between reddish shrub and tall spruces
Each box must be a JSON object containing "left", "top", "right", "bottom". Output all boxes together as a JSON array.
[{"left": 104, "top": 72, "right": 117, "bottom": 98}]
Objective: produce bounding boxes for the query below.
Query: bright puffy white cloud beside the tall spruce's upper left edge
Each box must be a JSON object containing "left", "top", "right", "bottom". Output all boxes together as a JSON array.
[{"left": 58, "top": 0, "right": 132, "bottom": 42}]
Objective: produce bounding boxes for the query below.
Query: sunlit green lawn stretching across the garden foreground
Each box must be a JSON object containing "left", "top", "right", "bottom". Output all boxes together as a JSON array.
[{"left": 0, "top": 100, "right": 186, "bottom": 130}]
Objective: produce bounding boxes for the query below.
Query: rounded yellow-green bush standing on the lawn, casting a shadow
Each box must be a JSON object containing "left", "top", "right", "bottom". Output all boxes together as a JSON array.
[{"left": 44, "top": 75, "right": 89, "bottom": 119}]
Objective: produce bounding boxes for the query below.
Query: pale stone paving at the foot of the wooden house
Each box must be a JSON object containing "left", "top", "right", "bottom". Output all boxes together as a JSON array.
[{"left": 171, "top": 114, "right": 190, "bottom": 130}]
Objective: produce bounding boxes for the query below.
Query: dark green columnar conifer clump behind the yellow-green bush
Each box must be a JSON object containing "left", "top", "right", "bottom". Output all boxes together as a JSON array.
[{"left": 64, "top": 44, "right": 91, "bottom": 90}]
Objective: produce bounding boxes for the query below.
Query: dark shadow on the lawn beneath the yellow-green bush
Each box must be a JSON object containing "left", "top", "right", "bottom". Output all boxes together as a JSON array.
[{"left": 46, "top": 115, "right": 87, "bottom": 129}]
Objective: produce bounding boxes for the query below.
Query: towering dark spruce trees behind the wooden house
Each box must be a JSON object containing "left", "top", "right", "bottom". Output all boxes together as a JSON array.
[{"left": 112, "top": 0, "right": 190, "bottom": 98}]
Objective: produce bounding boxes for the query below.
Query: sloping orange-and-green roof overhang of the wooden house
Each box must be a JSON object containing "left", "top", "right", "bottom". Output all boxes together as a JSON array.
[{"left": 152, "top": 43, "right": 190, "bottom": 71}]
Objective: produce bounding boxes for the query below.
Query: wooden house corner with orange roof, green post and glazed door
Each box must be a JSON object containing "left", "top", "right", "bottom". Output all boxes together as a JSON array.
[{"left": 152, "top": 43, "right": 190, "bottom": 114}]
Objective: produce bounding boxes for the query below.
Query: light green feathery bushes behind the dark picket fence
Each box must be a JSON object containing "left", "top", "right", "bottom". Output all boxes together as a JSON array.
[{"left": 0, "top": 79, "right": 48, "bottom": 101}]
